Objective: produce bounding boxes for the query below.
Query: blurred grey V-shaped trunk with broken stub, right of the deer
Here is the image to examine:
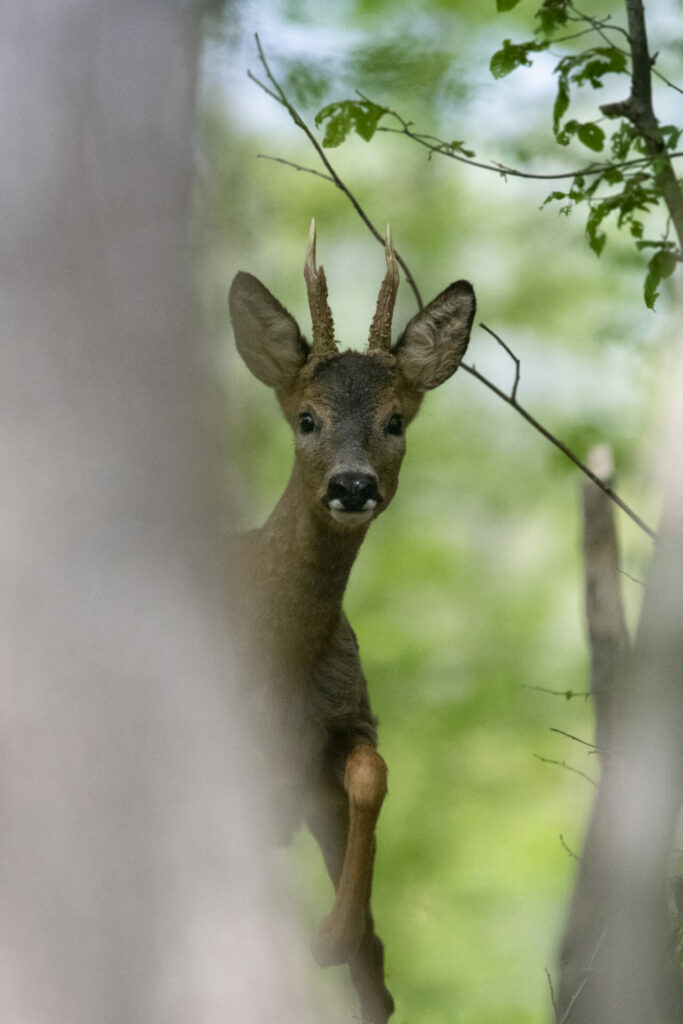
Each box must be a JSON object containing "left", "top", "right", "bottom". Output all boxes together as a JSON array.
[{"left": 556, "top": 350, "right": 683, "bottom": 1024}]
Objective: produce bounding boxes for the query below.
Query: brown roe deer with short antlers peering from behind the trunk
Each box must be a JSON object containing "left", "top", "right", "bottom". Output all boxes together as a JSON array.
[{"left": 230, "top": 222, "right": 475, "bottom": 1024}]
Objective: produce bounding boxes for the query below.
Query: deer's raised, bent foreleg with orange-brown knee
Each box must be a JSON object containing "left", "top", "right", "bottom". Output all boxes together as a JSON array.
[{"left": 313, "top": 746, "right": 387, "bottom": 966}]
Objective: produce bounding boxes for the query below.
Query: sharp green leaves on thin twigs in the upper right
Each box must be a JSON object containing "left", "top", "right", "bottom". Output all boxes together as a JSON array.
[{"left": 315, "top": 0, "right": 683, "bottom": 309}]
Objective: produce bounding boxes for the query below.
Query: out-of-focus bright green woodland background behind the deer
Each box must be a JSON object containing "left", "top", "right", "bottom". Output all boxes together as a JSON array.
[{"left": 195, "top": 0, "right": 681, "bottom": 1024}]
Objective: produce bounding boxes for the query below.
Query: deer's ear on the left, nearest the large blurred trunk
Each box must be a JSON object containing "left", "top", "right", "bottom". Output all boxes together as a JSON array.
[{"left": 229, "top": 271, "right": 310, "bottom": 388}]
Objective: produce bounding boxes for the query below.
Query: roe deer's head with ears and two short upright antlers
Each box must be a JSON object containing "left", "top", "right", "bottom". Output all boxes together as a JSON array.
[{"left": 229, "top": 222, "right": 475, "bottom": 528}]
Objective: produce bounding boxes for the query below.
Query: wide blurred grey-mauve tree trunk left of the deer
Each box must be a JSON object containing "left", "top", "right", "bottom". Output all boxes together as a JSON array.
[{"left": 0, "top": 0, "right": 317, "bottom": 1024}]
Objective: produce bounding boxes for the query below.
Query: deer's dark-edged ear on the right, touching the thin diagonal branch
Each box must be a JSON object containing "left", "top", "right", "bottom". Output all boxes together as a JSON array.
[{"left": 393, "top": 281, "right": 476, "bottom": 391}]
